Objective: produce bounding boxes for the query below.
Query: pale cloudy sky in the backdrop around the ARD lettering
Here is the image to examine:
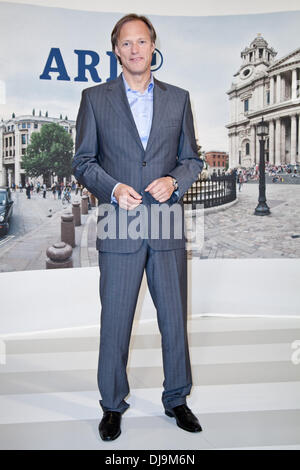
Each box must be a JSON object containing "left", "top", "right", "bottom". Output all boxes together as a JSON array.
[{"left": 0, "top": 3, "right": 300, "bottom": 151}]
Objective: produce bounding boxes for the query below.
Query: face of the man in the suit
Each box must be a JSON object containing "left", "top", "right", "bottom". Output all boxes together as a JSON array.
[{"left": 115, "top": 20, "right": 155, "bottom": 75}]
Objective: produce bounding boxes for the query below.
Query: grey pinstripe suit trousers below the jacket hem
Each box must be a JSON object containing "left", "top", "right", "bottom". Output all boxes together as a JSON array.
[{"left": 98, "top": 239, "right": 192, "bottom": 413}]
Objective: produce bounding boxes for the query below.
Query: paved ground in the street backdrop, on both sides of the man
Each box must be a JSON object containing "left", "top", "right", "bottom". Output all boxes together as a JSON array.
[{"left": 0, "top": 183, "right": 300, "bottom": 272}]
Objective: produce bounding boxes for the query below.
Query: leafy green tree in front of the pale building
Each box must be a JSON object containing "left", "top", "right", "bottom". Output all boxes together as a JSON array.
[{"left": 22, "top": 123, "right": 73, "bottom": 180}]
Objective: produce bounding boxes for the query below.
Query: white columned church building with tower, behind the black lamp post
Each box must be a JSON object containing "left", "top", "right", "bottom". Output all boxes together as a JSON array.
[{"left": 226, "top": 35, "right": 300, "bottom": 168}]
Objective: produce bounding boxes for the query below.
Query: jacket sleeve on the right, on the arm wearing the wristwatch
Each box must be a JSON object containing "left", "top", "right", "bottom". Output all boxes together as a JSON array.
[{"left": 168, "top": 92, "right": 204, "bottom": 199}]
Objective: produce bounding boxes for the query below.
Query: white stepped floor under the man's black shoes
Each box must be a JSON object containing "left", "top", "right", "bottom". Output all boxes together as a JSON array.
[{"left": 0, "top": 316, "right": 300, "bottom": 450}]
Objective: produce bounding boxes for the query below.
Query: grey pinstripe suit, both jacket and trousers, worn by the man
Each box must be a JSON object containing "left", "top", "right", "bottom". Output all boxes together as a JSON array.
[{"left": 73, "top": 75, "right": 203, "bottom": 412}]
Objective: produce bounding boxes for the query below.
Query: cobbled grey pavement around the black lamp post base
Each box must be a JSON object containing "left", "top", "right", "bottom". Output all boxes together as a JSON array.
[{"left": 189, "top": 183, "right": 300, "bottom": 259}]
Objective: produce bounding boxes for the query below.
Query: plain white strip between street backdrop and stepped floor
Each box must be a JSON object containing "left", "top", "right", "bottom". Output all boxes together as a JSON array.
[{"left": 0, "top": 259, "right": 300, "bottom": 336}]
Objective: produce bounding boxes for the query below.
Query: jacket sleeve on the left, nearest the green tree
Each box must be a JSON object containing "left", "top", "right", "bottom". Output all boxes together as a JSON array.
[{"left": 72, "top": 90, "right": 118, "bottom": 204}]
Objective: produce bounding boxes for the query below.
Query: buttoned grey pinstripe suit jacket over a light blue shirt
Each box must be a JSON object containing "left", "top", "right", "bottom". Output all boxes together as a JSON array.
[{"left": 72, "top": 75, "right": 203, "bottom": 253}]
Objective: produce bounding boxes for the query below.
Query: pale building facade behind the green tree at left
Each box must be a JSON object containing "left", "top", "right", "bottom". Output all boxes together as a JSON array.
[{"left": 0, "top": 113, "right": 75, "bottom": 187}]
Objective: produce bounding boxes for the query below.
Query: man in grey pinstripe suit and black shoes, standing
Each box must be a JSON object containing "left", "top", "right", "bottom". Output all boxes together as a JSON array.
[{"left": 73, "top": 14, "right": 203, "bottom": 440}]
